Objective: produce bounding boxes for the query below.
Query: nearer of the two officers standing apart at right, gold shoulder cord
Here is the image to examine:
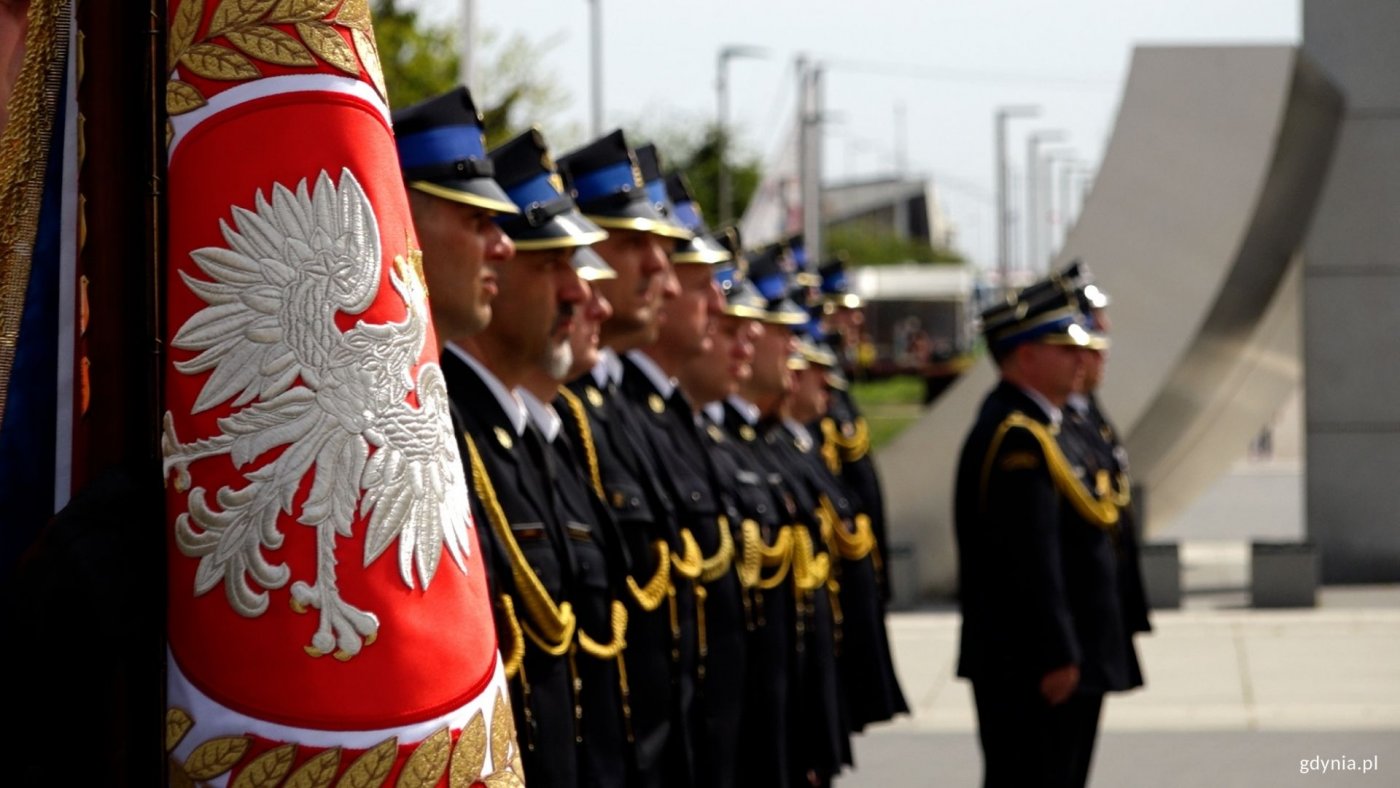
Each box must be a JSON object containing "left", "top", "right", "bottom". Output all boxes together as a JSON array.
[{"left": 955, "top": 272, "right": 1135, "bottom": 787}]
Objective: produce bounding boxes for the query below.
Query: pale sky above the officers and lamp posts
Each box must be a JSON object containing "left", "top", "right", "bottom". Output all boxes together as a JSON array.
[{"left": 400, "top": 0, "right": 1302, "bottom": 262}]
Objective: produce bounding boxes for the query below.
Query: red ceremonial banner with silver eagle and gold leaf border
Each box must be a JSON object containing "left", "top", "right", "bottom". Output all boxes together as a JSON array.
[{"left": 162, "top": 0, "right": 521, "bottom": 785}]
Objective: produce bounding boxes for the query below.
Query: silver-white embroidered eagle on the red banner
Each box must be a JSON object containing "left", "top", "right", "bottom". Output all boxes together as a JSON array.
[{"left": 161, "top": 169, "right": 470, "bottom": 659}]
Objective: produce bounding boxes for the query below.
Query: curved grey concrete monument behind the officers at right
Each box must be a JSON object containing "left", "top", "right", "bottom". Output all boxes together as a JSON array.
[{"left": 881, "top": 46, "right": 1341, "bottom": 595}]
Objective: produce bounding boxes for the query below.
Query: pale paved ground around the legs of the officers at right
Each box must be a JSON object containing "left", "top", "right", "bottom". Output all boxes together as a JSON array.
[{"left": 837, "top": 543, "right": 1400, "bottom": 788}]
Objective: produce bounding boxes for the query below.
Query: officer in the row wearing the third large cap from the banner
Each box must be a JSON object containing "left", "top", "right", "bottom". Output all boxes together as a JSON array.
[{"left": 560, "top": 130, "right": 697, "bottom": 787}]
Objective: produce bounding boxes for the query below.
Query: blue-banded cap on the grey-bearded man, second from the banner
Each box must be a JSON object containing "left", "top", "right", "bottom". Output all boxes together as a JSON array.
[{"left": 491, "top": 129, "right": 608, "bottom": 252}]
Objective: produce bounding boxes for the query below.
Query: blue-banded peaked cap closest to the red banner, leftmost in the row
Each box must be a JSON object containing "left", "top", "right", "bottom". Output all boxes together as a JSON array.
[{"left": 393, "top": 87, "right": 518, "bottom": 213}]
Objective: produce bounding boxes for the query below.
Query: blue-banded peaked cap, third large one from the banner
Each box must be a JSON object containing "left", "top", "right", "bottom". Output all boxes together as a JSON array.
[{"left": 559, "top": 129, "right": 691, "bottom": 238}]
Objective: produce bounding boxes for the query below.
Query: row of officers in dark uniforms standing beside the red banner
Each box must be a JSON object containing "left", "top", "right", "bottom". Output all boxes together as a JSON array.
[{"left": 393, "top": 88, "right": 907, "bottom": 788}]
